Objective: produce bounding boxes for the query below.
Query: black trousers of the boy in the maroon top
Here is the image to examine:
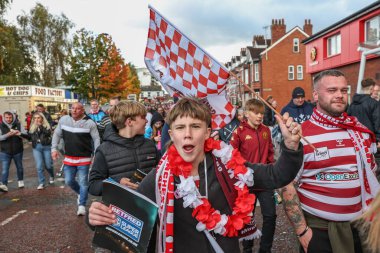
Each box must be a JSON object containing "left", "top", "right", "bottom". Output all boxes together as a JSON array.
[{"left": 242, "top": 190, "right": 277, "bottom": 253}]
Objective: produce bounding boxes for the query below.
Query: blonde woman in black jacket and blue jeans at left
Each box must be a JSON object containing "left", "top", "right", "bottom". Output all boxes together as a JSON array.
[{"left": 29, "top": 112, "right": 54, "bottom": 190}]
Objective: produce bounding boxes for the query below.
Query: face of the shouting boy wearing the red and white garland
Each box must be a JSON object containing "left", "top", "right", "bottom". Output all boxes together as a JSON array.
[{"left": 169, "top": 116, "right": 211, "bottom": 168}]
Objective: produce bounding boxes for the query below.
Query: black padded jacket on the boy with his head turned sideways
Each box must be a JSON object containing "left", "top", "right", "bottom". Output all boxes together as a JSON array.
[{"left": 88, "top": 124, "right": 159, "bottom": 196}]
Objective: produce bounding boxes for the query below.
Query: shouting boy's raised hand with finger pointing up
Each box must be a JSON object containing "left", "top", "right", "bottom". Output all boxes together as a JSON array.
[{"left": 275, "top": 112, "right": 301, "bottom": 150}]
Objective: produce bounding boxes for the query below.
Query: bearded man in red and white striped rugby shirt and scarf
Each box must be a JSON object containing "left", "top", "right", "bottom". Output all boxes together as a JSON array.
[{"left": 282, "top": 70, "right": 379, "bottom": 253}]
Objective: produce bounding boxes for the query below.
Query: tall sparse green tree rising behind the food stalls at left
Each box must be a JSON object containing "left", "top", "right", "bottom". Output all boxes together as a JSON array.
[{"left": 17, "top": 3, "right": 74, "bottom": 87}]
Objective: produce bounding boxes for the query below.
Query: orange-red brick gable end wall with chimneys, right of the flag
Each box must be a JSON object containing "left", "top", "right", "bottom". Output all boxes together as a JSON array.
[{"left": 260, "top": 19, "right": 313, "bottom": 110}]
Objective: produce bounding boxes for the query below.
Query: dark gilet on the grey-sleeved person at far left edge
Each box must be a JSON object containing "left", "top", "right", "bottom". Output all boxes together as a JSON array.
[{"left": 0, "top": 113, "right": 28, "bottom": 155}]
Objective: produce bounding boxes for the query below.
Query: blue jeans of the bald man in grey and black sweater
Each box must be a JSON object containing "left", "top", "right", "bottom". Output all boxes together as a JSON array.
[{"left": 63, "top": 165, "right": 90, "bottom": 206}]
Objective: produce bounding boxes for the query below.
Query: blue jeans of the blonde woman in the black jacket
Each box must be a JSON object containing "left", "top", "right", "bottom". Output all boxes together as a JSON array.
[{"left": 33, "top": 143, "right": 54, "bottom": 184}]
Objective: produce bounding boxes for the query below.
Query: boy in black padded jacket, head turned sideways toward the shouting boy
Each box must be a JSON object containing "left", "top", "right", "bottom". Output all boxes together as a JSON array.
[{"left": 88, "top": 102, "right": 159, "bottom": 196}]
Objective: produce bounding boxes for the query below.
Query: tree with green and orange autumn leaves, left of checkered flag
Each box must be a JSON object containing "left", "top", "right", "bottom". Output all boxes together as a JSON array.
[{"left": 69, "top": 29, "right": 140, "bottom": 101}]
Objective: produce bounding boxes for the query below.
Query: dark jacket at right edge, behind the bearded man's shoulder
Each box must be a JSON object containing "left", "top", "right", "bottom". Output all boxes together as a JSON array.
[{"left": 347, "top": 94, "right": 380, "bottom": 140}]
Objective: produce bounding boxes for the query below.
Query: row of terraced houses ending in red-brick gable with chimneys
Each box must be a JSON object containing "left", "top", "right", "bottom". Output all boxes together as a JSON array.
[{"left": 226, "top": 19, "right": 313, "bottom": 110}]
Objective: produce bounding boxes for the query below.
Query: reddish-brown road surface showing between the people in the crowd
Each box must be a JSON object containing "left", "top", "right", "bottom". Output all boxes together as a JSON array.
[{"left": 0, "top": 143, "right": 298, "bottom": 253}]
